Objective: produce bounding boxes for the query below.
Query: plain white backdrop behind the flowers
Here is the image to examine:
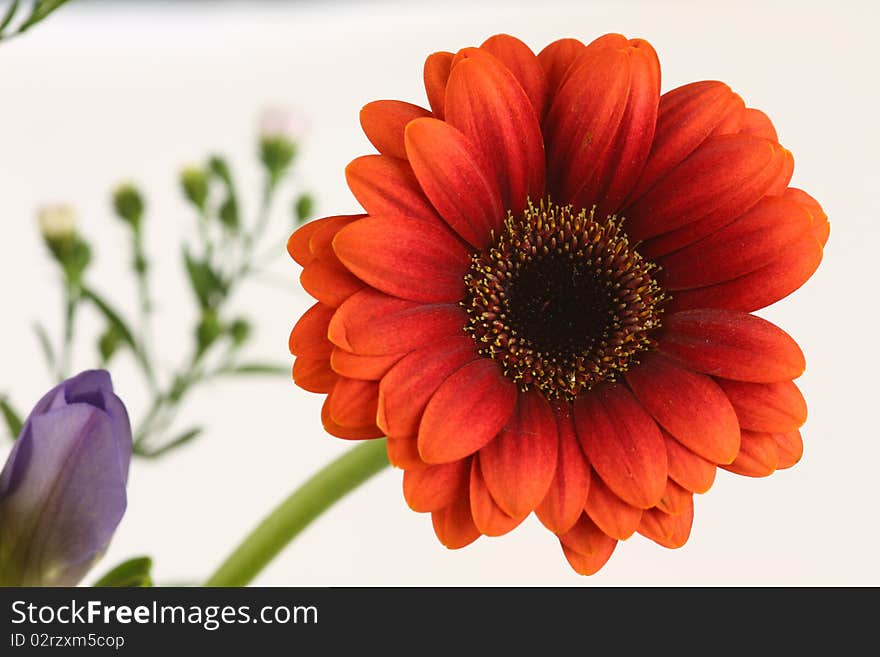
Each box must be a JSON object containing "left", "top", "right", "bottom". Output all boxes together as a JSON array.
[{"left": 0, "top": 1, "right": 880, "bottom": 586}]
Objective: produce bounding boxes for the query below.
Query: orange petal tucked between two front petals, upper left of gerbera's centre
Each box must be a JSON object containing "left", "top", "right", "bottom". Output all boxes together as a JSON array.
[{"left": 345, "top": 154, "right": 438, "bottom": 225}]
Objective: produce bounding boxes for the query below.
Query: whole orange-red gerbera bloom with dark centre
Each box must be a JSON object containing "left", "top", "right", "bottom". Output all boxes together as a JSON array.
[{"left": 289, "top": 34, "right": 829, "bottom": 574}]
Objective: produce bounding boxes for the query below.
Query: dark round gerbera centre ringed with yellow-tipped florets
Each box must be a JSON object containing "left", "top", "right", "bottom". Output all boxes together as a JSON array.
[{"left": 461, "top": 200, "right": 666, "bottom": 400}]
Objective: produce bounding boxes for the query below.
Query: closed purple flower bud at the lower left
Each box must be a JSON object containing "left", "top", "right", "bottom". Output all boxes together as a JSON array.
[{"left": 0, "top": 370, "right": 131, "bottom": 586}]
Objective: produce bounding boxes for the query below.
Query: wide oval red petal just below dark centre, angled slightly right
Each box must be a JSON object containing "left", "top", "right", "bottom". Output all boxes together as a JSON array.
[{"left": 574, "top": 383, "right": 667, "bottom": 509}]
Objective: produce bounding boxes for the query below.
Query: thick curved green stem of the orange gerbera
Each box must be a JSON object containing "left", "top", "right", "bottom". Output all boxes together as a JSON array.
[{"left": 205, "top": 438, "right": 388, "bottom": 586}]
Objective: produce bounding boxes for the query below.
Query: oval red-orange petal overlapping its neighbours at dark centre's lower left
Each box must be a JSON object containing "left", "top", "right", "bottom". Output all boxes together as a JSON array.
[{"left": 419, "top": 358, "right": 517, "bottom": 463}]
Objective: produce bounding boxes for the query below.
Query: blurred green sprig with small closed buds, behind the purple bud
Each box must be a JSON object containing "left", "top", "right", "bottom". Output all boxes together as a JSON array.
[{"left": 24, "top": 113, "right": 313, "bottom": 458}]
